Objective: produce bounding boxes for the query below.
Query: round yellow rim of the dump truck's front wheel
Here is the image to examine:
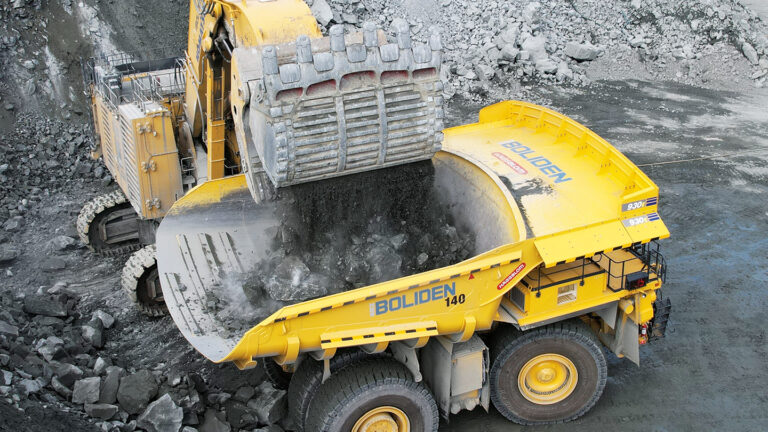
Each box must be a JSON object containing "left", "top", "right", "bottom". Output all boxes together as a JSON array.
[{"left": 517, "top": 354, "right": 579, "bottom": 405}]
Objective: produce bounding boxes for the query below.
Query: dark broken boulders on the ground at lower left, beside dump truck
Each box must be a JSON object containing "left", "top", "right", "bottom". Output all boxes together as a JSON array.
[{"left": 0, "top": 286, "right": 286, "bottom": 432}]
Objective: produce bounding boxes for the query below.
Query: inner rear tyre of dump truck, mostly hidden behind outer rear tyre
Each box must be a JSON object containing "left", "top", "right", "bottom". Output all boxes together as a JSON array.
[{"left": 287, "top": 348, "right": 378, "bottom": 432}]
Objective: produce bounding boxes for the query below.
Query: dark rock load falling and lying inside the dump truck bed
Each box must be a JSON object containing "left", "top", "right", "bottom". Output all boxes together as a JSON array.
[{"left": 209, "top": 161, "right": 475, "bottom": 331}]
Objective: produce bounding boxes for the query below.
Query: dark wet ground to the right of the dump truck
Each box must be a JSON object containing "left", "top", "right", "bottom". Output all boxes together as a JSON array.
[{"left": 441, "top": 82, "right": 768, "bottom": 432}]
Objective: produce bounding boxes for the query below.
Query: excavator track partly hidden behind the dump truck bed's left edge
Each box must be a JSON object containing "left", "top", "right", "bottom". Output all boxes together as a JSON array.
[{"left": 121, "top": 245, "right": 168, "bottom": 317}]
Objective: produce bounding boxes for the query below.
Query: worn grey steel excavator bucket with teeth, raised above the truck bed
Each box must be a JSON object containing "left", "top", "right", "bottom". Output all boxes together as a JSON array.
[{"left": 232, "top": 23, "right": 443, "bottom": 195}]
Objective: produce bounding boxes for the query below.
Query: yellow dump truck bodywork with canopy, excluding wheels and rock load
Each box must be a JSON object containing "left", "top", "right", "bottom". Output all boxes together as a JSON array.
[{"left": 158, "top": 102, "right": 669, "bottom": 367}]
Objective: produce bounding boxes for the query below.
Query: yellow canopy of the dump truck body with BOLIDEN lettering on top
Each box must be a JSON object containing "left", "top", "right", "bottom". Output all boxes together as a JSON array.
[{"left": 443, "top": 101, "right": 669, "bottom": 266}]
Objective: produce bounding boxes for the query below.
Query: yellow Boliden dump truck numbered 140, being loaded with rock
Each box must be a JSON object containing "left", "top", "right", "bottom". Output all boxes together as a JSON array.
[{"left": 158, "top": 101, "right": 670, "bottom": 431}]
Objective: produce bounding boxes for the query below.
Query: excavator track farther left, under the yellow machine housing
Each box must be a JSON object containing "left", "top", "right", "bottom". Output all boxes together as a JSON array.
[{"left": 77, "top": 190, "right": 141, "bottom": 256}]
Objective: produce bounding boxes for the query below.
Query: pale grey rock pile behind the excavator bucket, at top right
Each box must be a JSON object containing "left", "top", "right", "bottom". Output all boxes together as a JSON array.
[{"left": 312, "top": 0, "right": 768, "bottom": 97}]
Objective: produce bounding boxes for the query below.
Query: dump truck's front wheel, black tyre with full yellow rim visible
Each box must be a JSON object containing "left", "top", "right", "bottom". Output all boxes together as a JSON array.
[{"left": 490, "top": 320, "right": 608, "bottom": 425}]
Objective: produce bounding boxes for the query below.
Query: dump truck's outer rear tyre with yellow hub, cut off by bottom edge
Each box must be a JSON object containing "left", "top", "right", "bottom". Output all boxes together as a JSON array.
[{"left": 304, "top": 358, "right": 440, "bottom": 432}]
